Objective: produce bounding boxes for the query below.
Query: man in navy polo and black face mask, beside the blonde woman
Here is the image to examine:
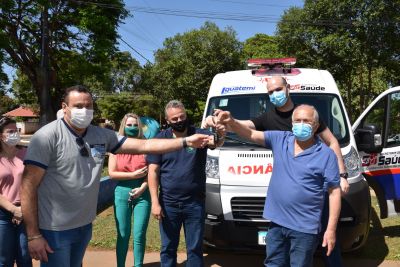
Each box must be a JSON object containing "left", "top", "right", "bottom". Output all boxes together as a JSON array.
[{"left": 147, "top": 100, "right": 222, "bottom": 267}]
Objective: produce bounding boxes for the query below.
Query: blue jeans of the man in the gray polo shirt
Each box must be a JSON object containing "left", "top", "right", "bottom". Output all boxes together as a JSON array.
[{"left": 40, "top": 223, "right": 92, "bottom": 267}]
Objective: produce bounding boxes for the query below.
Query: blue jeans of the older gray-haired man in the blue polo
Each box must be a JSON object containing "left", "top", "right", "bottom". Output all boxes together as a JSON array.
[{"left": 264, "top": 222, "right": 319, "bottom": 267}]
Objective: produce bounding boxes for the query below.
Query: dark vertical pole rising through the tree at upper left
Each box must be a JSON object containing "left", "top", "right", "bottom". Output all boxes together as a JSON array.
[{"left": 39, "top": 4, "right": 52, "bottom": 126}]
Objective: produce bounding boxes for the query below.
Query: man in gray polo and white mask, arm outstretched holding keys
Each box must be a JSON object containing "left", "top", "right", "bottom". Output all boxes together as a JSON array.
[{"left": 21, "top": 86, "right": 209, "bottom": 267}]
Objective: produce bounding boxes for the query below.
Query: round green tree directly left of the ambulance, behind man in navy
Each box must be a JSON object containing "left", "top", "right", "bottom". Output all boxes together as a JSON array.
[{"left": 143, "top": 22, "right": 242, "bottom": 122}]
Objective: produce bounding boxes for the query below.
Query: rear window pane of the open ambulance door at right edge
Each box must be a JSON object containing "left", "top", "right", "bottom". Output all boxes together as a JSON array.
[{"left": 386, "top": 93, "right": 400, "bottom": 147}]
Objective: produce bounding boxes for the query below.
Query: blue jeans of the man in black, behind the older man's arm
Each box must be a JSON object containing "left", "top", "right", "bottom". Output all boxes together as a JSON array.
[{"left": 321, "top": 193, "right": 343, "bottom": 267}]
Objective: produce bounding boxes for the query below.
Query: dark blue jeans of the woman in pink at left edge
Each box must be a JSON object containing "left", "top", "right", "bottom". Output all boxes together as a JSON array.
[{"left": 0, "top": 209, "right": 32, "bottom": 267}]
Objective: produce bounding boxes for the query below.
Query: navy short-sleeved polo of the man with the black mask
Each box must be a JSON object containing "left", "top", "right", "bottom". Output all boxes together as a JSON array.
[{"left": 147, "top": 127, "right": 211, "bottom": 203}]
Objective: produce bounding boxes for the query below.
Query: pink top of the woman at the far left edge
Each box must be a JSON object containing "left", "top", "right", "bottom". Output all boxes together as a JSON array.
[{"left": 0, "top": 148, "right": 26, "bottom": 204}]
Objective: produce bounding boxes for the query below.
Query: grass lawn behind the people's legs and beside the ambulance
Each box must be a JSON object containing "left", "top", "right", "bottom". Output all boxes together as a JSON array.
[{"left": 89, "top": 197, "right": 400, "bottom": 260}]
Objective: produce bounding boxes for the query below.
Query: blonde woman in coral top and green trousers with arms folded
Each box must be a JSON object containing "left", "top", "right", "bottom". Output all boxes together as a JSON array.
[{"left": 108, "top": 113, "right": 151, "bottom": 267}]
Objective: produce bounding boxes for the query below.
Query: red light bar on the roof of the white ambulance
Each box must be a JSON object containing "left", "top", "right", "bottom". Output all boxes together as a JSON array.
[{"left": 247, "top": 57, "right": 296, "bottom": 75}]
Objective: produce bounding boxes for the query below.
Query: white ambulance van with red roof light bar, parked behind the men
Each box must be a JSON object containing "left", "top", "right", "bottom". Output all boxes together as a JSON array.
[{"left": 203, "top": 58, "right": 376, "bottom": 251}]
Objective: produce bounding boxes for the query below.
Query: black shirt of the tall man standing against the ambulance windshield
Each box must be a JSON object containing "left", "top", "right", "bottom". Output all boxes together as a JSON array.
[{"left": 251, "top": 107, "right": 326, "bottom": 134}]
